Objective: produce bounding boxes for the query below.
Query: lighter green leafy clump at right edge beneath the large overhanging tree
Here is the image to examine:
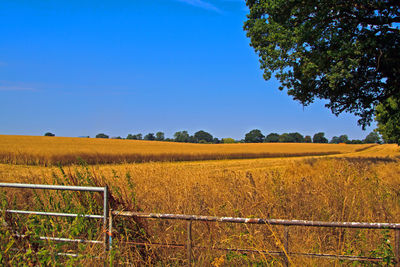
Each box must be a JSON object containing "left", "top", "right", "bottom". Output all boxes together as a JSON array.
[{"left": 375, "top": 95, "right": 400, "bottom": 145}]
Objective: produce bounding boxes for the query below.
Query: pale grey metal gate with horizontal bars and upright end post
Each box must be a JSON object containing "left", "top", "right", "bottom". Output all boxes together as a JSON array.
[{"left": 0, "top": 183, "right": 111, "bottom": 257}]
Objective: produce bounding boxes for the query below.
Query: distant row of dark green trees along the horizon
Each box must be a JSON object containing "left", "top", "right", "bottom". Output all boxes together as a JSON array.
[{"left": 45, "top": 129, "right": 382, "bottom": 144}]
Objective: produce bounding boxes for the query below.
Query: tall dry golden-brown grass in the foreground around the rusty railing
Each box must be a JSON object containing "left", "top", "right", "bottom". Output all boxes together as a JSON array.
[{"left": 0, "top": 154, "right": 400, "bottom": 266}]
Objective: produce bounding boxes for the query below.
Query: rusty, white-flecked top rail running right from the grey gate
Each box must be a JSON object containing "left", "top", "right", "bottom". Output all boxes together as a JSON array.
[{"left": 112, "top": 211, "right": 400, "bottom": 229}]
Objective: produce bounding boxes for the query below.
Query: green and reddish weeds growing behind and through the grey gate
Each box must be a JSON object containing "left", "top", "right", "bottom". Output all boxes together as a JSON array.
[{"left": 0, "top": 168, "right": 103, "bottom": 266}]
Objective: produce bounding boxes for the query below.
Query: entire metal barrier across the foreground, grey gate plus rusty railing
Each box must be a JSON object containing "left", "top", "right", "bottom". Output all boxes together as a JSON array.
[{"left": 0, "top": 183, "right": 400, "bottom": 266}]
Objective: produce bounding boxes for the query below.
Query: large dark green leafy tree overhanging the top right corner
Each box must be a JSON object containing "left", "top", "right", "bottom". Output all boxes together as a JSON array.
[{"left": 244, "top": 0, "right": 400, "bottom": 127}]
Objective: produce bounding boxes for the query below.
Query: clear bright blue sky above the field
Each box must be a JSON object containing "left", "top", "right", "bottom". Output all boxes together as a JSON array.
[{"left": 0, "top": 0, "right": 372, "bottom": 139}]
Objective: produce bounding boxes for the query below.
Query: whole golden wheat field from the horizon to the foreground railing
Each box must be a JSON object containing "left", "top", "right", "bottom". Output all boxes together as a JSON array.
[{"left": 0, "top": 136, "right": 400, "bottom": 266}]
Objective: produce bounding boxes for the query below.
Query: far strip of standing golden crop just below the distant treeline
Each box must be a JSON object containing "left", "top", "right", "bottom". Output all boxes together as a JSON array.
[{"left": 0, "top": 135, "right": 371, "bottom": 165}]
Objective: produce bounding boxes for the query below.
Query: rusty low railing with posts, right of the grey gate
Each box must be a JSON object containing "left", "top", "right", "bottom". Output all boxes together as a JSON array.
[{"left": 109, "top": 211, "right": 400, "bottom": 266}]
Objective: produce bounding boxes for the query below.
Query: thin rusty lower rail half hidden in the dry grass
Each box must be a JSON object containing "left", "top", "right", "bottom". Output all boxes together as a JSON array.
[{"left": 122, "top": 242, "right": 383, "bottom": 262}]
